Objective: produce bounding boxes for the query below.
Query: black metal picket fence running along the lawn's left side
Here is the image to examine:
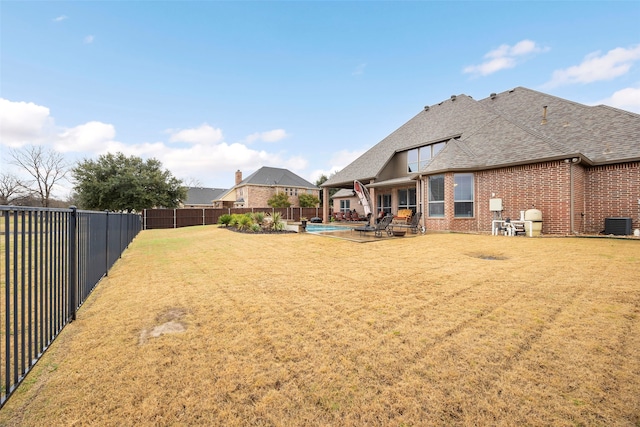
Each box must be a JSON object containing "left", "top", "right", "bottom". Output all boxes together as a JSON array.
[{"left": 0, "top": 206, "right": 142, "bottom": 407}]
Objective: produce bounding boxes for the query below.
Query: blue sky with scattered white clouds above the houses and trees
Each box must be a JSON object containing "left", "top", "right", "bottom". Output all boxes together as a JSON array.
[{"left": 0, "top": 0, "right": 640, "bottom": 201}]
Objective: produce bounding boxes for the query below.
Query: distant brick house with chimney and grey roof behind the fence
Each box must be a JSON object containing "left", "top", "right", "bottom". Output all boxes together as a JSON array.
[{"left": 214, "top": 166, "right": 320, "bottom": 208}]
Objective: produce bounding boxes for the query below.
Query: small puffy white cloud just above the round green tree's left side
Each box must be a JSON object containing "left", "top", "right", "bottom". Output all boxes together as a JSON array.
[{"left": 54, "top": 121, "right": 116, "bottom": 153}]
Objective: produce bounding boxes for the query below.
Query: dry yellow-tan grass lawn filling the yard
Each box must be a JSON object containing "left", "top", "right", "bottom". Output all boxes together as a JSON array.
[{"left": 0, "top": 226, "right": 640, "bottom": 426}]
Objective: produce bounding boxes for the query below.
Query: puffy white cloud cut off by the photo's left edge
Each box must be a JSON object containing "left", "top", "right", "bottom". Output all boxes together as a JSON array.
[{"left": 0, "top": 98, "right": 53, "bottom": 148}]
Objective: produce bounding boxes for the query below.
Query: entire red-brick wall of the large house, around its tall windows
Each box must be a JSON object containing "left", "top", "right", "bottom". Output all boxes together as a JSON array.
[{"left": 423, "top": 160, "right": 640, "bottom": 235}]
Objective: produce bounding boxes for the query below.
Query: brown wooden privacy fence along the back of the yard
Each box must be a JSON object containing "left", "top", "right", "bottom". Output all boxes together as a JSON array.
[{"left": 142, "top": 207, "right": 322, "bottom": 230}]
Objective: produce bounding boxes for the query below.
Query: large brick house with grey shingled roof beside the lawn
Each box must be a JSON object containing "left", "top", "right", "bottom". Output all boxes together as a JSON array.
[{"left": 322, "top": 87, "right": 640, "bottom": 235}]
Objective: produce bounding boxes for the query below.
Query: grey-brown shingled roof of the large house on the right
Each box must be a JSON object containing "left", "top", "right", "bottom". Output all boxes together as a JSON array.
[{"left": 322, "top": 87, "right": 640, "bottom": 187}]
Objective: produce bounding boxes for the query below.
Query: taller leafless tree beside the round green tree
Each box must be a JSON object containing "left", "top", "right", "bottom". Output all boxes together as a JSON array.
[{"left": 11, "top": 145, "right": 68, "bottom": 207}]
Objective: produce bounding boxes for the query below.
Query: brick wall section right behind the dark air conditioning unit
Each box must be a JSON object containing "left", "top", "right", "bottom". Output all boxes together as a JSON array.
[{"left": 584, "top": 162, "right": 640, "bottom": 233}]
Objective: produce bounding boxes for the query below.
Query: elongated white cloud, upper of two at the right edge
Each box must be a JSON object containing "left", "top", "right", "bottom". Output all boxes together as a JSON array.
[{"left": 544, "top": 45, "right": 640, "bottom": 88}]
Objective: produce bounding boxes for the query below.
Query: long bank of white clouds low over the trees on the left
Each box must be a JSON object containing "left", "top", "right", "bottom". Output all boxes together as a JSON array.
[{"left": 0, "top": 98, "right": 310, "bottom": 189}]
